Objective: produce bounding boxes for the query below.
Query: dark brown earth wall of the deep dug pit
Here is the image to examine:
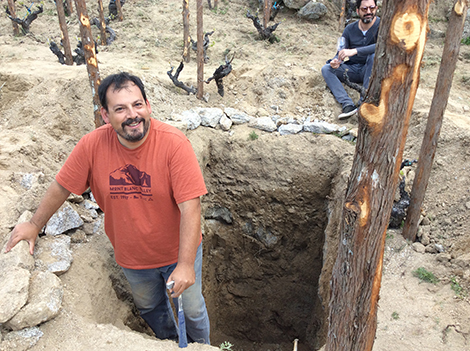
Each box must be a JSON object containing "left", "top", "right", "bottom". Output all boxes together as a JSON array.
[{"left": 189, "top": 126, "right": 354, "bottom": 350}]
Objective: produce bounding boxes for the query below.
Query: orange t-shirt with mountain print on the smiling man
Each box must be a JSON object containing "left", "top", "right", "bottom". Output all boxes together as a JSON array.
[{"left": 56, "top": 119, "right": 207, "bottom": 269}]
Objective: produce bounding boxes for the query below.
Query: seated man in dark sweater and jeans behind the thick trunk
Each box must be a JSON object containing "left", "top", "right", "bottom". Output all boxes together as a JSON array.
[{"left": 321, "top": 0, "right": 380, "bottom": 119}]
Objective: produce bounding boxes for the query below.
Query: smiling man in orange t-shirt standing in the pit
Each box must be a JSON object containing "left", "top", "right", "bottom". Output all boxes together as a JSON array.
[{"left": 6, "top": 72, "right": 210, "bottom": 344}]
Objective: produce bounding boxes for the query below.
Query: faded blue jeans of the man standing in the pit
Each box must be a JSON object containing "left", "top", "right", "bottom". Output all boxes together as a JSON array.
[{"left": 122, "top": 244, "right": 210, "bottom": 344}]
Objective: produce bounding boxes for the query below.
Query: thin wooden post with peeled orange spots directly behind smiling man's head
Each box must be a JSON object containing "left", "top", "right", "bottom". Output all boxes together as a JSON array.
[{"left": 75, "top": 0, "right": 102, "bottom": 128}]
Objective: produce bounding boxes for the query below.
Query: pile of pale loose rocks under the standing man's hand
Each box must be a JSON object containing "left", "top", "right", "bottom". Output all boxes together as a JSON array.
[{"left": 0, "top": 187, "right": 103, "bottom": 350}]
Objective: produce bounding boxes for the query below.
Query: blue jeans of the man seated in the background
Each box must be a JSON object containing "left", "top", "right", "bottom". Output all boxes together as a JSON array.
[{"left": 321, "top": 54, "right": 375, "bottom": 107}]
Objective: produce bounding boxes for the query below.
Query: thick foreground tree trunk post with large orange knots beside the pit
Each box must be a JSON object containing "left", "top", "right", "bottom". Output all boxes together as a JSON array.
[{"left": 326, "top": 0, "right": 429, "bottom": 351}]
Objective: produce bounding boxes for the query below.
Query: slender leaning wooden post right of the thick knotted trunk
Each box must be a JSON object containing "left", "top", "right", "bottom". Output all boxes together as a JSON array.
[{"left": 403, "top": 0, "right": 468, "bottom": 241}]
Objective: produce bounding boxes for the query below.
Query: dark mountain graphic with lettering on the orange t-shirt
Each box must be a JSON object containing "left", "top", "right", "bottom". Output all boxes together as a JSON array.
[{"left": 109, "top": 164, "right": 152, "bottom": 200}]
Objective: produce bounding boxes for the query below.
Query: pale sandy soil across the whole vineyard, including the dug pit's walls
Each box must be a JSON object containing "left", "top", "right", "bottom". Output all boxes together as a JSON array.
[{"left": 0, "top": 0, "right": 470, "bottom": 351}]
